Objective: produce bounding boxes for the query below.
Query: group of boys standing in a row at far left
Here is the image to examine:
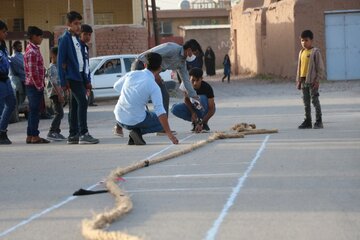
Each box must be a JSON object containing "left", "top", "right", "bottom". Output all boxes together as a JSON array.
[{"left": 0, "top": 11, "right": 99, "bottom": 144}]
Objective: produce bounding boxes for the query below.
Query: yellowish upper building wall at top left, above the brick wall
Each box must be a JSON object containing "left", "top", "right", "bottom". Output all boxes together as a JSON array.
[{"left": 0, "top": 0, "right": 135, "bottom": 31}]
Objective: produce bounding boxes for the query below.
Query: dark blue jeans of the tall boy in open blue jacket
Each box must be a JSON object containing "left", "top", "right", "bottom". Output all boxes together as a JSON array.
[{"left": 68, "top": 80, "right": 88, "bottom": 136}]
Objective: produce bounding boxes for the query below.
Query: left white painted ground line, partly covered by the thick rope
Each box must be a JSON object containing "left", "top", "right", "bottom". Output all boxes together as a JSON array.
[{"left": 0, "top": 134, "right": 195, "bottom": 237}]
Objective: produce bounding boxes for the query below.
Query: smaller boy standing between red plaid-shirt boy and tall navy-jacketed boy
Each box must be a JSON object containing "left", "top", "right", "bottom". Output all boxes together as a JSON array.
[{"left": 45, "top": 47, "right": 66, "bottom": 141}]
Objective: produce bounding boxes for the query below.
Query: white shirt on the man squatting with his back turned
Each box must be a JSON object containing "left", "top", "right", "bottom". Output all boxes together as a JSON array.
[{"left": 114, "top": 69, "right": 166, "bottom": 126}]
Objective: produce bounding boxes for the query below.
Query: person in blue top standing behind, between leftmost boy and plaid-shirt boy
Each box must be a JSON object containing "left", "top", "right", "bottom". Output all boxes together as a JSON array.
[{"left": 10, "top": 41, "right": 26, "bottom": 105}]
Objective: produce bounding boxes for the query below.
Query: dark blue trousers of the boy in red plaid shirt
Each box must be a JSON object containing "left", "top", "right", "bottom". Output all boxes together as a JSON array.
[{"left": 26, "top": 86, "right": 44, "bottom": 136}]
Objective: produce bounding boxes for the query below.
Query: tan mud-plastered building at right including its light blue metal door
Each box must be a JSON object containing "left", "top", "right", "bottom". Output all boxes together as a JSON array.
[{"left": 230, "top": 0, "right": 360, "bottom": 80}]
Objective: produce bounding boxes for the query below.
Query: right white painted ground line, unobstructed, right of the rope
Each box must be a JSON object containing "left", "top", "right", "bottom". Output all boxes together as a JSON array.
[{"left": 205, "top": 135, "right": 270, "bottom": 240}]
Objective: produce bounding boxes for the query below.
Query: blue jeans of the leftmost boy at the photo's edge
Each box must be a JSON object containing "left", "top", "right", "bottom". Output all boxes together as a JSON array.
[{"left": 0, "top": 79, "right": 16, "bottom": 131}]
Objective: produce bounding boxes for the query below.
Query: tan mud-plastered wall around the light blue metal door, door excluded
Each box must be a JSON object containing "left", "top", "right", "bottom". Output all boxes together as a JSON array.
[{"left": 230, "top": 0, "right": 360, "bottom": 78}]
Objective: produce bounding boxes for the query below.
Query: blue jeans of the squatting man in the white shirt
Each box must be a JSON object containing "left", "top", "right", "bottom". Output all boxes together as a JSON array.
[{"left": 119, "top": 111, "right": 163, "bottom": 134}]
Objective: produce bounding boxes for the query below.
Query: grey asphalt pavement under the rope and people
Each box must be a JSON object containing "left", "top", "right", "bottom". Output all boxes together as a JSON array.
[{"left": 0, "top": 79, "right": 360, "bottom": 240}]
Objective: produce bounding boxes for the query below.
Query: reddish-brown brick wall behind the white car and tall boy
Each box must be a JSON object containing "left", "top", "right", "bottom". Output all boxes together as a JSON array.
[{"left": 54, "top": 25, "right": 148, "bottom": 56}]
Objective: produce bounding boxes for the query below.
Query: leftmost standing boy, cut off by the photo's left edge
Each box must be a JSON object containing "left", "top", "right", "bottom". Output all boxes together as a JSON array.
[{"left": 0, "top": 20, "right": 16, "bottom": 144}]
